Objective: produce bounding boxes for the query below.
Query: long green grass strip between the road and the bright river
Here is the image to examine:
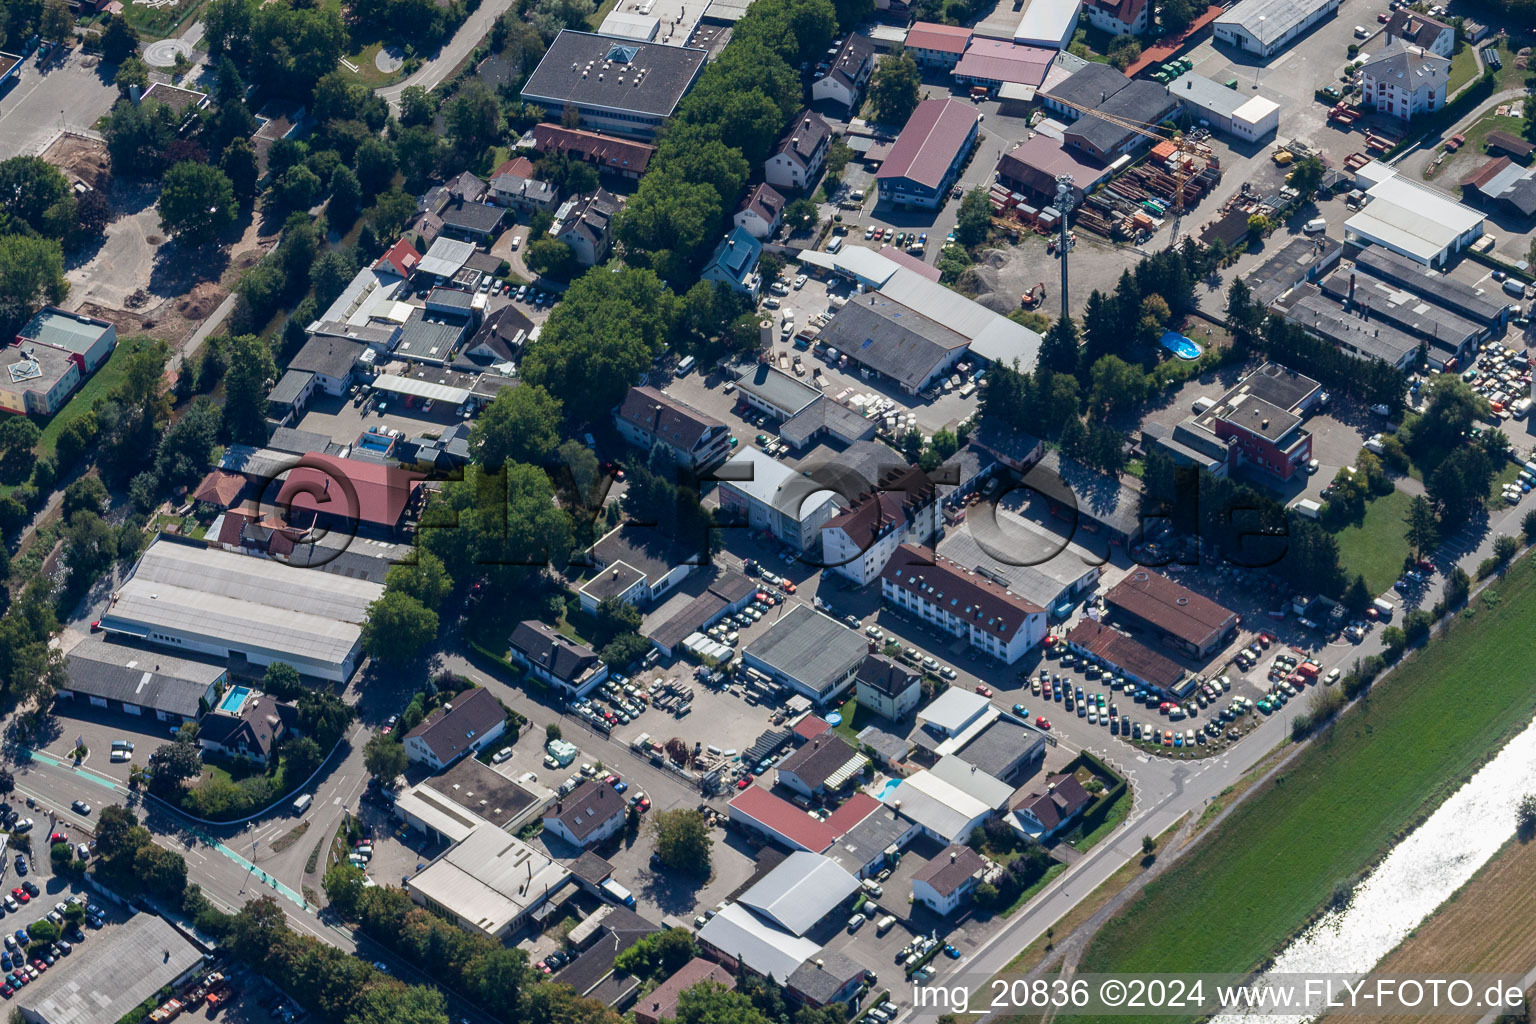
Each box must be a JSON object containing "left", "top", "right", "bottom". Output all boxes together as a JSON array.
[{"left": 1080, "top": 559, "right": 1536, "bottom": 1024}]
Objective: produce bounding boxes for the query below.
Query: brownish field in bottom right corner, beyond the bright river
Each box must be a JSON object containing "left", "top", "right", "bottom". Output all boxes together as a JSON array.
[{"left": 1349, "top": 841, "right": 1536, "bottom": 1024}]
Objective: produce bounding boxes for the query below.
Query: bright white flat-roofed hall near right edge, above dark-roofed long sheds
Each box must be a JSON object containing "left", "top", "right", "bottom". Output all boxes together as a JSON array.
[{"left": 1344, "top": 160, "right": 1484, "bottom": 267}]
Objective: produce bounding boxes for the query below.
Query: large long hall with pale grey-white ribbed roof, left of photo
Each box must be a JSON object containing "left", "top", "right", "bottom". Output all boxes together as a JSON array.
[{"left": 101, "top": 537, "right": 384, "bottom": 682}]
